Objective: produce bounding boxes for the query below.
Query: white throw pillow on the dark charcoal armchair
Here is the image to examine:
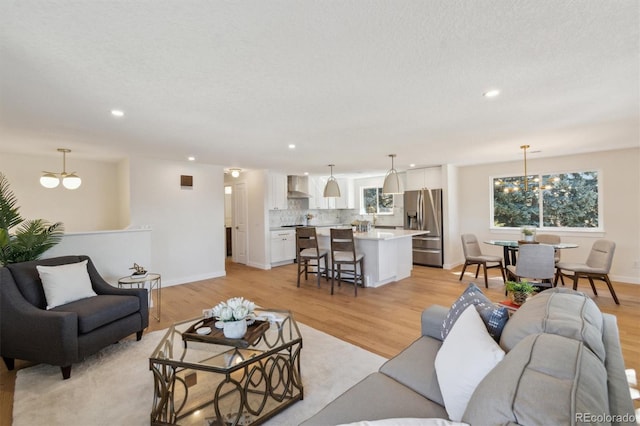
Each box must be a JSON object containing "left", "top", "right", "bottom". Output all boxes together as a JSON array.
[{"left": 36, "top": 260, "right": 97, "bottom": 309}]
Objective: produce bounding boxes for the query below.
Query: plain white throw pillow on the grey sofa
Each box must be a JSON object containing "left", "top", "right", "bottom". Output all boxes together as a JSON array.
[{"left": 435, "top": 305, "right": 504, "bottom": 421}]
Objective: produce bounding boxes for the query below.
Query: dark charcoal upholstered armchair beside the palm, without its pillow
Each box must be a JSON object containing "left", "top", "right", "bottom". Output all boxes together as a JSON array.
[{"left": 0, "top": 256, "right": 149, "bottom": 379}]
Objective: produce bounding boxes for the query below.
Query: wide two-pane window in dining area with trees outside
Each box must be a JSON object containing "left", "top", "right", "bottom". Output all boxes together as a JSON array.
[{"left": 491, "top": 171, "right": 602, "bottom": 230}]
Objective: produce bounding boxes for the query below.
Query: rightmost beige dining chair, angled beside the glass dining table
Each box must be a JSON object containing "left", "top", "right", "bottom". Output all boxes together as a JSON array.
[{"left": 553, "top": 240, "right": 620, "bottom": 305}]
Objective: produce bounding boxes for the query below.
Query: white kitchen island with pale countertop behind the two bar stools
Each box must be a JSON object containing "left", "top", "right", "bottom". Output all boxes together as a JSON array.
[{"left": 317, "top": 228, "right": 426, "bottom": 287}]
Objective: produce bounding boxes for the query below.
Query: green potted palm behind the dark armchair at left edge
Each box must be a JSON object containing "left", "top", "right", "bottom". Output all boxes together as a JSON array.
[{"left": 0, "top": 173, "right": 64, "bottom": 266}]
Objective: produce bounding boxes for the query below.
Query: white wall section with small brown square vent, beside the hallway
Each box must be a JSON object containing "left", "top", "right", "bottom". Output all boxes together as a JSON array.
[{"left": 130, "top": 158, "right": 226, "bottom": 285}]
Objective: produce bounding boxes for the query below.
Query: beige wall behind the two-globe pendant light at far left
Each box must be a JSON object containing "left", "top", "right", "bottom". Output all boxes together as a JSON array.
[{"left": 0, "top": 152, "right": 122, "bottom": 232}]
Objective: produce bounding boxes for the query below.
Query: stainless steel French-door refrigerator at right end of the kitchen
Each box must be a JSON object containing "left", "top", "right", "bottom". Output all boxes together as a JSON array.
[{"left": 404, "top": 189, "right": 444, "bottom": 268}]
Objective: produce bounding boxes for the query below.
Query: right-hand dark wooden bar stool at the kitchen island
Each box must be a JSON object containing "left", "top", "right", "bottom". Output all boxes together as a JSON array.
[{"left": 330, "top": 228, "right": 364, "bottom": 296}]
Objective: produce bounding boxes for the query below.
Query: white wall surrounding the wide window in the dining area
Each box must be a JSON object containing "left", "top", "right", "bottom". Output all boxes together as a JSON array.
[{"left": 456, "top": 148, "right": 640, "bottom": 284}]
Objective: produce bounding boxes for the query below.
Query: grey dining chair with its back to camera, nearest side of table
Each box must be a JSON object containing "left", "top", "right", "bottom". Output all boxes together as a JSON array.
[{"left": 507, "top": 244, "right": 555, "bottom": 287}]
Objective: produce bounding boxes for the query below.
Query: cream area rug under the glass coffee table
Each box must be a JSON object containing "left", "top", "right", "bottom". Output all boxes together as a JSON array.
[{"left": 13, "top": 323, "right": 385, "bottom": 426}]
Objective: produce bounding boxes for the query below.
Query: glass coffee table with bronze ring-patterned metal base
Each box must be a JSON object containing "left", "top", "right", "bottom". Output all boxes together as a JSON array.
[{"left": 149, "top": 309, "right": 303, "bottom": 426}]
